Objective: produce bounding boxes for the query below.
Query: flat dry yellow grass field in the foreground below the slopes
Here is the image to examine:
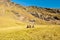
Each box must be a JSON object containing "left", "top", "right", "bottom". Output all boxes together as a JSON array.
[{"left": 0, "top": 25, "right": 60, "bottom": 40}]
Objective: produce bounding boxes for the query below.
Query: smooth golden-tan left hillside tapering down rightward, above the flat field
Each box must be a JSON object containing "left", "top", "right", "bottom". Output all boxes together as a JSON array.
[{"left": 0, "top": 2, "right": 50, "bottom": 27}]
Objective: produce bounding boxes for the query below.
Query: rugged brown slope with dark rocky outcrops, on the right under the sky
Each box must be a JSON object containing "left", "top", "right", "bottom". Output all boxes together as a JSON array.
[{"left": 27, "top": 6, "right": 60, "bottom": 24}]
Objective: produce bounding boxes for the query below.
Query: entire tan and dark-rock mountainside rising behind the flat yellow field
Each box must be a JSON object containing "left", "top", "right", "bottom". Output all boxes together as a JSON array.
[{"left": 0, "top": 0, "right": 60, "bottom": 26}]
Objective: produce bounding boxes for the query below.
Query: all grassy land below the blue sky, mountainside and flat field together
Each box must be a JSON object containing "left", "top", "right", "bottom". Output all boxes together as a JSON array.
[{"left": 0, "top": 0, "right": 60, "bottom": 40}]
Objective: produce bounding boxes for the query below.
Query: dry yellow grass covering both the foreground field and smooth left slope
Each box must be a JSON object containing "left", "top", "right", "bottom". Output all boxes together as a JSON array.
[{"left": 0, "top": 2, "right": 60, "bottom": 40}]
